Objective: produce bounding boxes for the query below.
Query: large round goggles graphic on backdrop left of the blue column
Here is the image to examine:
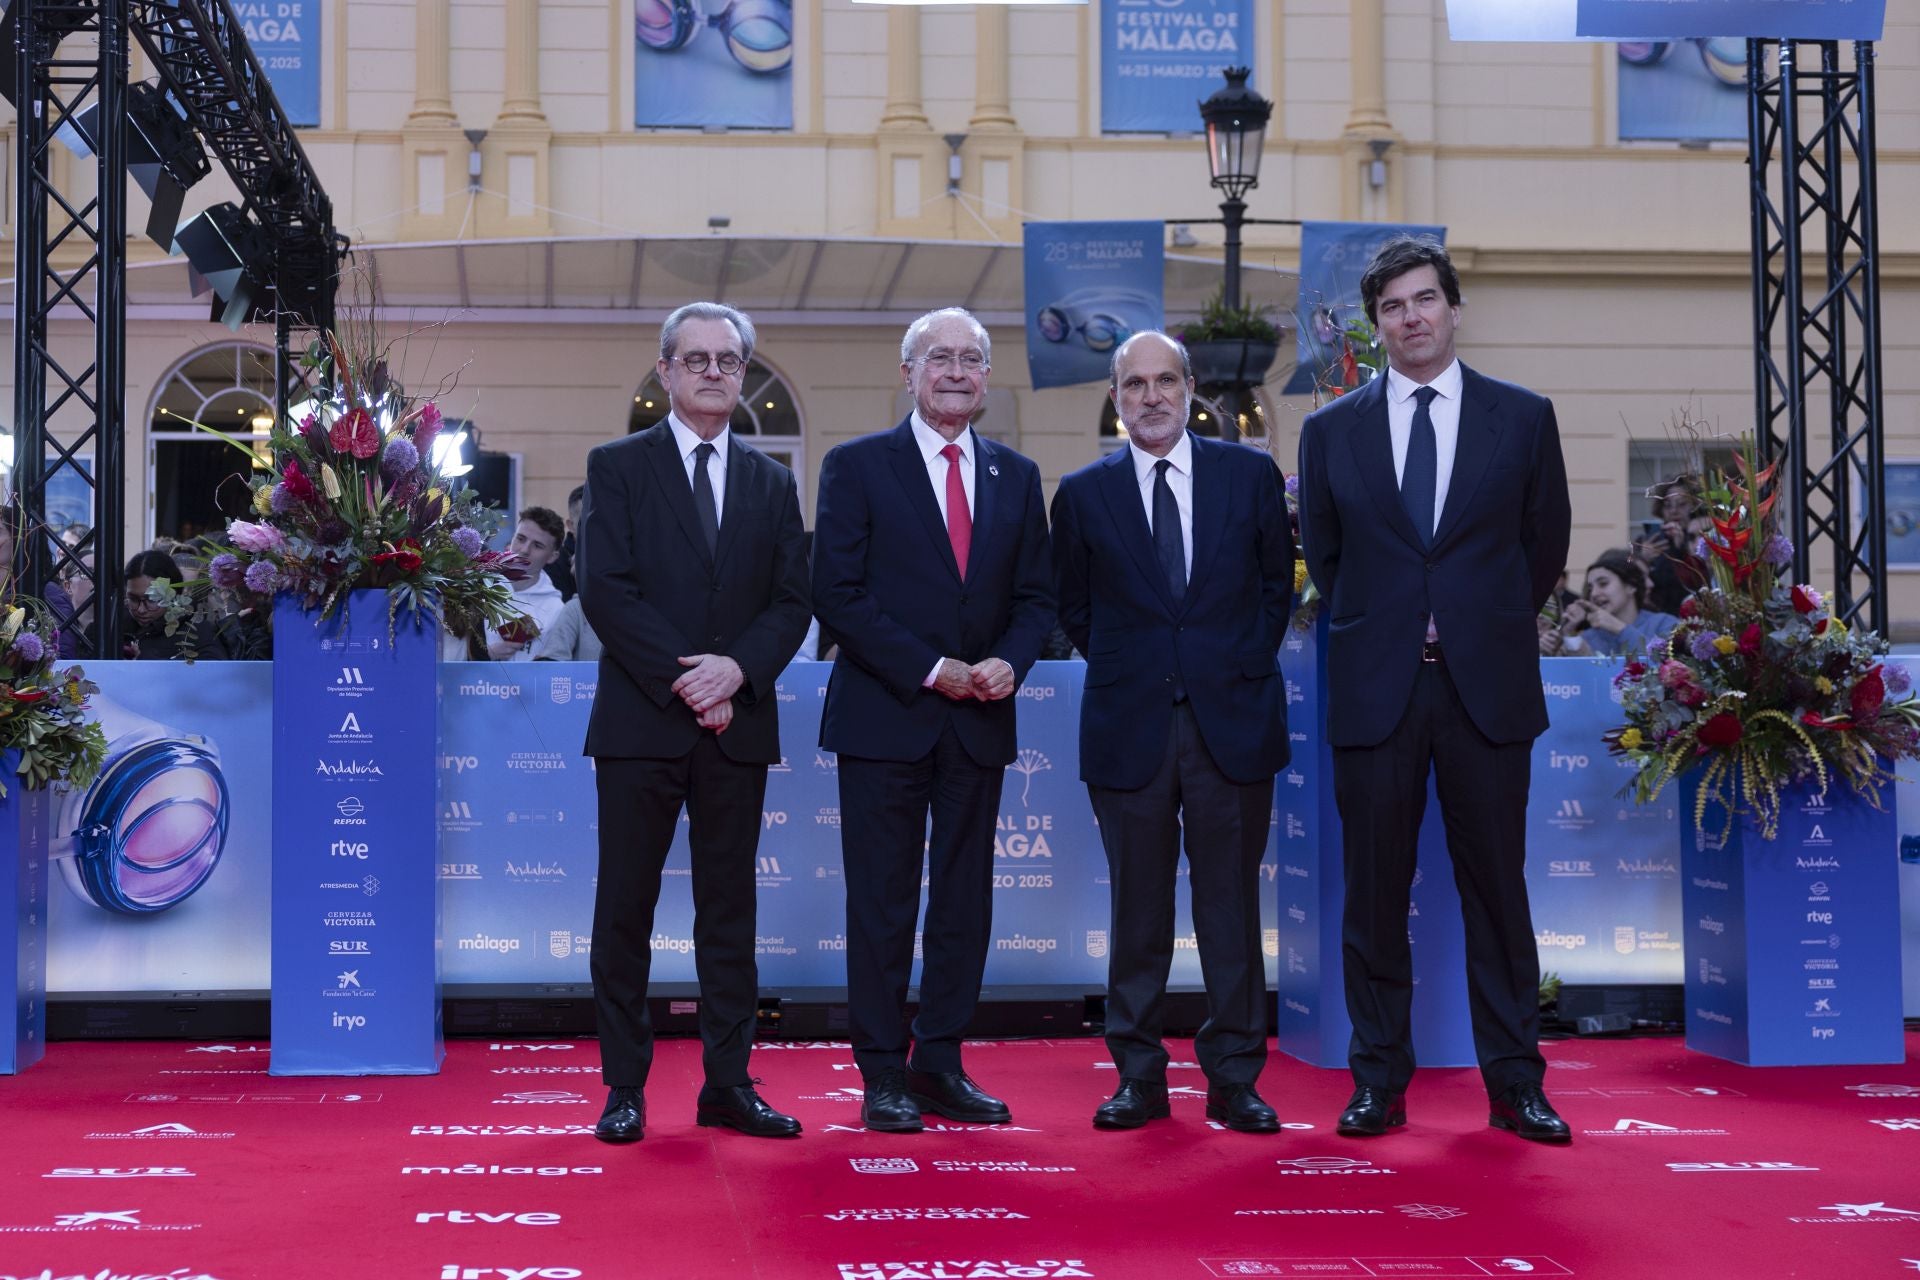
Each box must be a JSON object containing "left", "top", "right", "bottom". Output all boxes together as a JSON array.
[{"left": 50, "top": 695, "right": 232, "bottom": 915}]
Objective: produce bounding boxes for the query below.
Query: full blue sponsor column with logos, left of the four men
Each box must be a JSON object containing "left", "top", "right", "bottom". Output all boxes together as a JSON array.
[{"left": 269, "top": 591, "right": 444, "bottom": 1075}]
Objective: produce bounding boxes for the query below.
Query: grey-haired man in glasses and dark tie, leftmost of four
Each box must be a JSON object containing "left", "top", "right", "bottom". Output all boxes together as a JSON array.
[{"left": 578, "top": 303, "right": 808, "bottom": 1142}]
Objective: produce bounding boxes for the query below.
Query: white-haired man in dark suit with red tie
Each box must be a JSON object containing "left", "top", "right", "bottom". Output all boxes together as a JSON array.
[{"left": 814, "top": 307, "right": 1054, "bottom": 1132}]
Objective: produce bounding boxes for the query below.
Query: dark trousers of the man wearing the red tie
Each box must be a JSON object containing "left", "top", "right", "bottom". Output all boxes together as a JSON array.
[{"left": 839, "top": 727, "right": 1006, "bottom": 1075}]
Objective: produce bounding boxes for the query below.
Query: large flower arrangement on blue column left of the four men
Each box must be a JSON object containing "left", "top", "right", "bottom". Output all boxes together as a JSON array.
[{"left": 194, "top": 334, "right": 518, "bottom": 635}]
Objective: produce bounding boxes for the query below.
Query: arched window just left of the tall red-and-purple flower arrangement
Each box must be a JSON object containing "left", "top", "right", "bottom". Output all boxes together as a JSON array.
[{"left": 146, "top": 342, "right": 273, "bottom": 545}]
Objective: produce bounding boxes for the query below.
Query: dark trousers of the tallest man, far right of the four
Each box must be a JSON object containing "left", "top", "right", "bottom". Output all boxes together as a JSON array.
[{"left": 1332, "top": 660, "right": 1546, "bottom": 1096}]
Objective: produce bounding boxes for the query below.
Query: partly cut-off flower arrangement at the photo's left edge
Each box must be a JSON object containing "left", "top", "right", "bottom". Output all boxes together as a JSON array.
[{"left": 0, "top": 594, "right": 108, "bottom": 796}]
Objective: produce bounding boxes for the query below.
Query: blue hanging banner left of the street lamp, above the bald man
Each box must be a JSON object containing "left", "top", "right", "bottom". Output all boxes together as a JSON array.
[{"left": 1025, "top": 223, "right": 1167, "bottom": 390}]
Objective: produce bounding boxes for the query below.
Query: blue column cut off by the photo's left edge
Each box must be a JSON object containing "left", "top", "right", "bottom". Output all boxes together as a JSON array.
[{"left": 0, "top": 750, "right": 46, "bottom": 1075}]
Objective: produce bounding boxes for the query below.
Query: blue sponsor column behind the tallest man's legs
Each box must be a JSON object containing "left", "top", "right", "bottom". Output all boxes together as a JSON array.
[{"left": 1275, "top": 620, "right": 1475, "bottom": 1067}]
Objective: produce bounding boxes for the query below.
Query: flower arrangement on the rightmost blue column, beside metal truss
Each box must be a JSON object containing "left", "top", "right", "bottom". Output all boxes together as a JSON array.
[{"left": 1605, "top": 436, "right": 1920, "bottom": 839}]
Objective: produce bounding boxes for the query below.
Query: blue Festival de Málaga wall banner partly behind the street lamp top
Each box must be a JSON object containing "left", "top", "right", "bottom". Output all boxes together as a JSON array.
[{"left": 1100, "top": 0, "right": 1254, "bottom": 132}]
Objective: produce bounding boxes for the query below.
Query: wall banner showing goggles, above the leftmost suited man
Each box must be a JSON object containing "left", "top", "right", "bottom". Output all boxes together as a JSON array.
[{"left": 634, "top": 0, "right": 793, "bottom": 129}]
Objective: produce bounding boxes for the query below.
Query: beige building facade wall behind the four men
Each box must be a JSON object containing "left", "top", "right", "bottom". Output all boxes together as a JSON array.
[{"left": 0, "top": 0, "right": 1920, "bottom": 614}]
